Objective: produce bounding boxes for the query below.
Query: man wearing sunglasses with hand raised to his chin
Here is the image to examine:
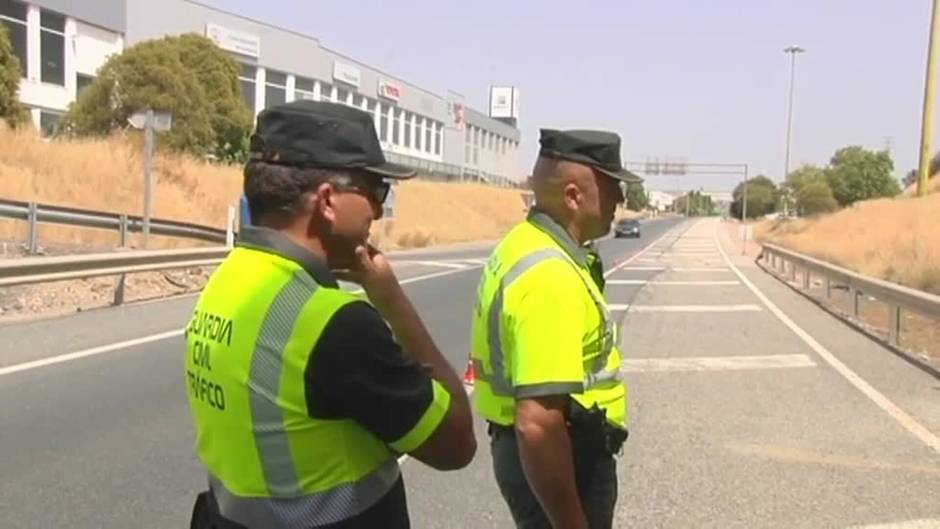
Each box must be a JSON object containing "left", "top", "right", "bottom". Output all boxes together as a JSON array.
[{"left": 185, "top": 101, "right": 476, "bottom": 529}]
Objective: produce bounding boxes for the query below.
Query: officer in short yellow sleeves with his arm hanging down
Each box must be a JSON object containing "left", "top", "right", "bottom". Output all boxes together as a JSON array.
[{"left": 472, "top": 130, "right": 639, "bottom": 529}]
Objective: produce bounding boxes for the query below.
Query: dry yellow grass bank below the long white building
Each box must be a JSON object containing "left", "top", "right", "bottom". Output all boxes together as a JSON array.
[{"left": 0, "top": 130, "right": 525, "bottom": 252}]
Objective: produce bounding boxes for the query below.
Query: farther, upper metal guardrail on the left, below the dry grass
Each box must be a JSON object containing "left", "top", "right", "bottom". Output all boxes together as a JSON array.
[{"left": 0, "top": 199, "right": 228, "bottom": 254}]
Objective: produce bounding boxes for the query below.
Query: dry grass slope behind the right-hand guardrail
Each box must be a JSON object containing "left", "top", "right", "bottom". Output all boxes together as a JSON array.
[{"left": 757, "top": 192, "right": 940, "bottom": 294}]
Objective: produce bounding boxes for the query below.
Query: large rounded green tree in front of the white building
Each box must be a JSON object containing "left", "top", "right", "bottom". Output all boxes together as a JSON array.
[{"left": 63, "top": 35, "right": 251, "bottom": 156}]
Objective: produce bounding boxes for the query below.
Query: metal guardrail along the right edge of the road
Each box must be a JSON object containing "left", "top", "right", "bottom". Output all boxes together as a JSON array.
[{"left": 761, "top": 244, "right": 940, "bottom": 346}]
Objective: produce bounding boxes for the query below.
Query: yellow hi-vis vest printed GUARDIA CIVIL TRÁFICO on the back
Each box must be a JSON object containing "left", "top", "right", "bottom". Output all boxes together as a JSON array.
[{"left": 186, "top": 248, "right": 400, "bottom": 529}]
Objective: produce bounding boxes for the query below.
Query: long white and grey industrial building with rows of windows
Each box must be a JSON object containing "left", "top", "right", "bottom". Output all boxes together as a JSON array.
[{"left": 0, "top": 0, "right": 523, "bottom": 183}]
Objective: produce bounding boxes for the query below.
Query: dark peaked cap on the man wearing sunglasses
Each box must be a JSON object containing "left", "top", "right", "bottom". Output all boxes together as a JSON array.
[{"left": 249, "top": 100, "right": 415, "bottom": 180}]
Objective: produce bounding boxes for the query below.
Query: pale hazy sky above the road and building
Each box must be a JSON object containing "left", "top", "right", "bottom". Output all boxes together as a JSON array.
[{"left": 204, "top": 0, "right": 930, "bottom": 190}]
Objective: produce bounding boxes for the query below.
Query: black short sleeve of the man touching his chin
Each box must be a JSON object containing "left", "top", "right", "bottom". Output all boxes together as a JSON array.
[{"left": 304, "top": 301, "right": 434, "bottom": 443}]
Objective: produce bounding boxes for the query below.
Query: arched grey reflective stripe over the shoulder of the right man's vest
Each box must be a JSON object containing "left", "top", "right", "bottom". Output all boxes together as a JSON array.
[{"left": 471, "top": 248, "right": 620, "bottom": 397}]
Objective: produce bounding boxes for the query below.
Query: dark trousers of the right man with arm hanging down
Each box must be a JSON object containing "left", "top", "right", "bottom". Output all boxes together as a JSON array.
[{"left": 490, "top": 427, "right": 617, "bottom": 529}]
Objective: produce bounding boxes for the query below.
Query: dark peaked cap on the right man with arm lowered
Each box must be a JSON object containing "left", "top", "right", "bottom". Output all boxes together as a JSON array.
[{"left": 539, "top": 129, "right": 643, "bottom": 184}]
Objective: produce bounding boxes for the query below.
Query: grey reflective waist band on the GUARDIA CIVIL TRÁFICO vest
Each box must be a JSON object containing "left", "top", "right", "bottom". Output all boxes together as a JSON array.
[{"left": 209, "top": 459, "right": 400, "bottom": 529}]
